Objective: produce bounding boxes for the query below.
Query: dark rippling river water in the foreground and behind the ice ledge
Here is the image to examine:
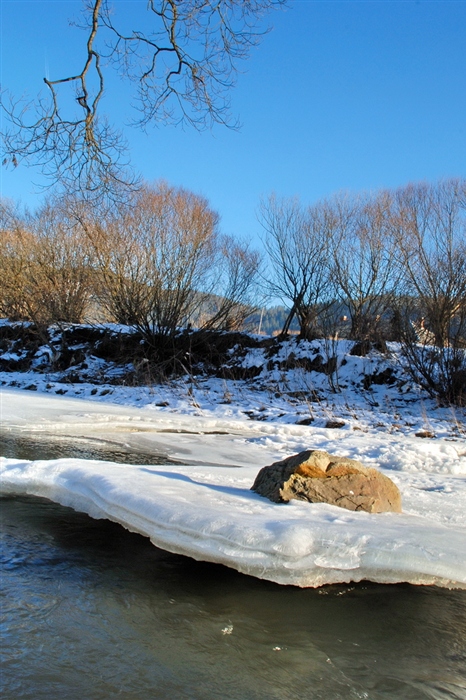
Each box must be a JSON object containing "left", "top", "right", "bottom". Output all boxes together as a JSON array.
[{"left": 0, "top": 436, "right": 466, "bottom": 700}]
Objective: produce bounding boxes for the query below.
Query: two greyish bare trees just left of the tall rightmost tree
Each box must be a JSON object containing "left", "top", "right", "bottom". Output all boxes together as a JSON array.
[{"left": 260, "top": 192, "right": 399, "bottom": 340}]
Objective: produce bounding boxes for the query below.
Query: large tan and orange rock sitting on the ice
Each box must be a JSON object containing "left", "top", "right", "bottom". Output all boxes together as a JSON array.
[{"left": 252, "top": 450, "right": 401, "bottom": 513}]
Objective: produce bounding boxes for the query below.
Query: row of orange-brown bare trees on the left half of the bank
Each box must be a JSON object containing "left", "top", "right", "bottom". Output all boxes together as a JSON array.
[{"left": 0, "top": 182, "right": 259, "bottom": 340}]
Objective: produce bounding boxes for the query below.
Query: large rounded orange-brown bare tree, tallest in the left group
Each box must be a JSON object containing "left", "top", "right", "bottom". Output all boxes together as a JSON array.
[{"left": 74, "top": 182, "right": 218, "bottom": 340}]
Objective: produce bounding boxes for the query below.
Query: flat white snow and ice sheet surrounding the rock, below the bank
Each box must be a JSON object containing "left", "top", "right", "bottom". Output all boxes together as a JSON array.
[{"left": 1, "top": 390, "right": 466, "bottom": 588}]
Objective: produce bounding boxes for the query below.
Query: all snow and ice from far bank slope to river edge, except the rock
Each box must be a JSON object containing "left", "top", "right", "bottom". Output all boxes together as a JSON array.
[{"left": 0, "top": 334, "right": 466, "bottom": 588}]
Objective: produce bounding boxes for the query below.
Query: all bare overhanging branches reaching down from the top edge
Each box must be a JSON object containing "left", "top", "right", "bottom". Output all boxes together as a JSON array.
[{"left": 1, "top": 0, "right": 285, "bottom": 191}]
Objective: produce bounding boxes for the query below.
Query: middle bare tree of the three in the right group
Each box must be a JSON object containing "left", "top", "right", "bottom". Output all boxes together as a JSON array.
[{"left": 328, "top": 192, "right": 397, "bottom": 340}]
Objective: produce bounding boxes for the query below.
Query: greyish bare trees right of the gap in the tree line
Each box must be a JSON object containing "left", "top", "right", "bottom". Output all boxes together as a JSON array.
[{"left": 259, "top": 179, "right": 466, "bottom": 347}]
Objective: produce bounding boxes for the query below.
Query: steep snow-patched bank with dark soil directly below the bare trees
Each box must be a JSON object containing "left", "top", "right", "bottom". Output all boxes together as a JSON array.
[{"left": 0, "top": 319, "right": 466, "bottom": 441}]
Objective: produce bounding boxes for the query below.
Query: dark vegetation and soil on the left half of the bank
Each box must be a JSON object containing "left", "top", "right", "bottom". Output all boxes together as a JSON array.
[{"left": 0, "top": 323, "right": 268, "bottom": 384}]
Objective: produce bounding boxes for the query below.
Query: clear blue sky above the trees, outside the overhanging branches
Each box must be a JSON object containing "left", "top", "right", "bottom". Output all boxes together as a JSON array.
[{"left": 0, "top": 0, "right": 466, "bottom": 247}]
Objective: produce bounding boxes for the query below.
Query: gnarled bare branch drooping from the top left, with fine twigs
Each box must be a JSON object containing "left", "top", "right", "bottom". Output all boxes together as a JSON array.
[{"left": 1, "top": 0, "right": 131, "bottom": 193}]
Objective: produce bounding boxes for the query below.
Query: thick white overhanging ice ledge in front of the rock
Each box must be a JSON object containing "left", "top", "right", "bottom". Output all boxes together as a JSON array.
[{"left": 0, "top": 458, "right": 466, "bottom": 588}]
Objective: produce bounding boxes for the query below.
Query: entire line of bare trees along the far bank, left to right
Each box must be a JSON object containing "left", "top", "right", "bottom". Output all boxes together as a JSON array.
[{"left": 0, "top": 179, "right": 466, "bottom": 400}]
